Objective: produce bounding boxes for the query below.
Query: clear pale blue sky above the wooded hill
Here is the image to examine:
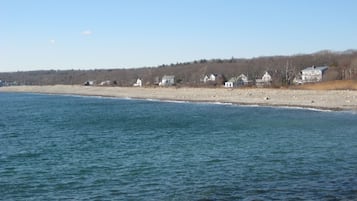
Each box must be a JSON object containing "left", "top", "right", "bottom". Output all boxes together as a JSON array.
[{"left": 0, "top": 0, "right": 357, "bottom": 72}]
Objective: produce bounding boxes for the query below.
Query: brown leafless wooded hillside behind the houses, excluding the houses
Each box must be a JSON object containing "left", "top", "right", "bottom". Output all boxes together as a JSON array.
[{"left": 0, "top": 50, "right": 357, "bottom": 86}]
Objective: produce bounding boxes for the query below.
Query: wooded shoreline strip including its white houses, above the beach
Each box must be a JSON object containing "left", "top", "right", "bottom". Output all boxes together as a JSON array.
[{"left": 0, "top": 50, "right": 357, "bottom": 88}]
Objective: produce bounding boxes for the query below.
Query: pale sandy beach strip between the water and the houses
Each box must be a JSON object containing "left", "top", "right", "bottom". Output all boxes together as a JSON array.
[{"left": 0, "top": 85, "right": 357, "bottom": 111}]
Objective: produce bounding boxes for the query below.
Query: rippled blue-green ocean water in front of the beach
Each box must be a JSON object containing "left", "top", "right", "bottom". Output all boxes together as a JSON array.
[{"left": 0, "top": 93, "right": 357, "bottom": 200}]
